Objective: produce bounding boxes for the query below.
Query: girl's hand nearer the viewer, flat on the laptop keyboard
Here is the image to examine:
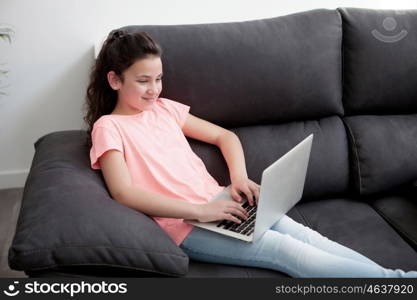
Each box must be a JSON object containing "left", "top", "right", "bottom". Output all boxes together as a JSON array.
[{"left": 197, "top": 200, "right": 248, "bottom": 224}]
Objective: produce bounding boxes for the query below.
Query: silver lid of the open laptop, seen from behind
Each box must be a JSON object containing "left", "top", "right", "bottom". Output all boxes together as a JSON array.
[{"left": 253, "top": 134, "right": 313, "bottom": 241}]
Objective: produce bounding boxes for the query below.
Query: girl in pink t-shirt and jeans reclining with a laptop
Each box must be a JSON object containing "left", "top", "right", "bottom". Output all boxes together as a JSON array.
[{"left": 84, "top": 30, "right": 417, "bottom": 277}]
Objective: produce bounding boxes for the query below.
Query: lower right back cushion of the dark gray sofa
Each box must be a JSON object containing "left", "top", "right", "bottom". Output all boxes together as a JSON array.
[{"left": 344, "top": 115, "right": 417, "bottom": 195}]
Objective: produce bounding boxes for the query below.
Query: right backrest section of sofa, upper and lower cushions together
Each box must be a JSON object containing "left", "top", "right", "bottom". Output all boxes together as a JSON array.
[{"left": 338, "top": 8, "right": 417, "bottom": 195}]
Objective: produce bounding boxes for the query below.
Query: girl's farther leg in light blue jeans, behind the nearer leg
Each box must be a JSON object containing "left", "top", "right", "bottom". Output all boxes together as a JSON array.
[{"left": 271, "top": 215, "right": 380, "bottom": 266}]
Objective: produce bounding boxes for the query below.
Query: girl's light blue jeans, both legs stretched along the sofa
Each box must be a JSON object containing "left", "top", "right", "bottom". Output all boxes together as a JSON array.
[{"left": 180, "top": 216, "right": 417, "bottom": 277}]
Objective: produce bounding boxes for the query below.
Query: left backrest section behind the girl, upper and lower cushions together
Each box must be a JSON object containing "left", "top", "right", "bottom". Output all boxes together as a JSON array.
[{"left": 124, "top": 9, "right": 349, "bottom": 202}]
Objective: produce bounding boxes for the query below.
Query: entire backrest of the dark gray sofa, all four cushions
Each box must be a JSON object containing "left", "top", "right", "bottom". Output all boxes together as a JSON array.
[{"left": 124, "top": 8, "right": 417, "bottom": 198}]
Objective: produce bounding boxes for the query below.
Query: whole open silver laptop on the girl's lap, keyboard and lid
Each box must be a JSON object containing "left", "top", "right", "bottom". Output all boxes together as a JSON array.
[{"left": 184, "top": 134, "right": 313, "bottom": 242}]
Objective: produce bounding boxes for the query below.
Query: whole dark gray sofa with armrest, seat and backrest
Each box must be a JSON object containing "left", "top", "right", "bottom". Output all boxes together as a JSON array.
[{"left": 9, "top": 8, "right": 417, "bottom": 277}]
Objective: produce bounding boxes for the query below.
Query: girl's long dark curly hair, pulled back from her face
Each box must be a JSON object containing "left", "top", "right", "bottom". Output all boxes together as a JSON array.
[{"left": 84, "top": 29, "right": 162, "bottom": 148}]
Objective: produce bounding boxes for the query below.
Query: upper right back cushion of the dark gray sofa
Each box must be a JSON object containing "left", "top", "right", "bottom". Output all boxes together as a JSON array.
[{"left": 338, "top": 8, "right": 417, "bottom": 115}]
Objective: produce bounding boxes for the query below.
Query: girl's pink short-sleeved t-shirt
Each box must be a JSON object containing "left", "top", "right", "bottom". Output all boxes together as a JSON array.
[{"left": 90, "top": 98, "right": 225, "bottom": 245}]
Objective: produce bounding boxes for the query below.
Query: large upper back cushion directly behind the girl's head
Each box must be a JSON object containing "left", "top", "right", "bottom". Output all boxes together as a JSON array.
[{"left": 125, "top": 9, "right": 343, "bottom": 127}]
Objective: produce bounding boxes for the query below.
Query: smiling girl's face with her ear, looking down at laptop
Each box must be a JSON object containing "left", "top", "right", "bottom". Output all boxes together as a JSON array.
[{"left": 107, "top": 56, "right": 162, "bottom": 115}]
